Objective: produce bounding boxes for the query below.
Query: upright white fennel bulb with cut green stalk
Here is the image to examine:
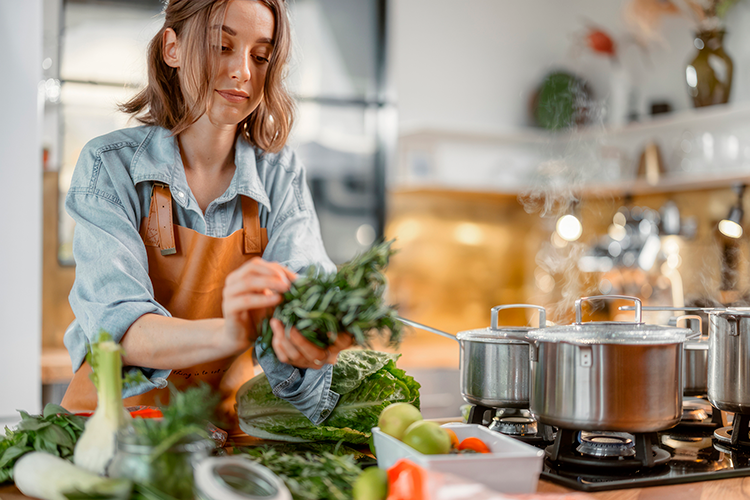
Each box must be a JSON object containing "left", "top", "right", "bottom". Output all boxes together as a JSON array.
[{"left": 73, "top": 332, "right": 132, "bottom": 475}]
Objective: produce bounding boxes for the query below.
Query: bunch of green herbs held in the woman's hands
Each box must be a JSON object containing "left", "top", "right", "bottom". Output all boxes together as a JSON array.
[{"left": 260, "top": 241, "right": 402, "bottom": 347}]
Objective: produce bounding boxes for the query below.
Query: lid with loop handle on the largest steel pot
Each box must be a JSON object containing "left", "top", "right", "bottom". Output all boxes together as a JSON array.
[{"left": 527, "top": 295, "right": 692, "bottom": 345}]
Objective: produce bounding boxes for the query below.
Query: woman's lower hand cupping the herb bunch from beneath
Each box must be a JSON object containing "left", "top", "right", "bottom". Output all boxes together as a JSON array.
[{"left": 271, "top": 318, "right": 352, "bottom": 370}]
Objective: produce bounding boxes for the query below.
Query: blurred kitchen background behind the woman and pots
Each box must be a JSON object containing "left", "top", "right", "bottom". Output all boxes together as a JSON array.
[{"left": 0, "top": 0, "right": 750, "bottom": 420}]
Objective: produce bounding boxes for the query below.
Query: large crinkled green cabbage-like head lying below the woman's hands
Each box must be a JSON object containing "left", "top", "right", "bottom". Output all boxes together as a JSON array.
[{"left": 237, "top": 349, "right": 420, "bottom": 444}]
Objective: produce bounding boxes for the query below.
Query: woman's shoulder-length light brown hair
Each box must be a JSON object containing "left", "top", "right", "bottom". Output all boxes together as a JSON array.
[{"left": 120, "top": 0, "right": 294, "bottom": 153}]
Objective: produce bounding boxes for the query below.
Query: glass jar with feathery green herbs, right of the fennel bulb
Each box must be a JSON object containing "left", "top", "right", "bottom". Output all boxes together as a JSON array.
[{"left": 109, "top": 432, "right": 216, "bottom": 500}]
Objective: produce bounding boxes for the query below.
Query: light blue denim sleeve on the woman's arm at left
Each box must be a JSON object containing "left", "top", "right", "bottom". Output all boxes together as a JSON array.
[{"left": 64, "top": 148, "right": 170, "bottom": 397}]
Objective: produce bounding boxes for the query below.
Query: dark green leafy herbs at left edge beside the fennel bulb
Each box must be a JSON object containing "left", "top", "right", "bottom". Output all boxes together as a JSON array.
[{"left": 0, "top": 404, "right": 86, "bottom": 483}]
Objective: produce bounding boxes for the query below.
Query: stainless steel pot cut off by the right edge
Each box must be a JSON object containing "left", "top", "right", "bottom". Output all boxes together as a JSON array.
[{"left": 708, "top": 309, "right": 750, "bottom": 413}]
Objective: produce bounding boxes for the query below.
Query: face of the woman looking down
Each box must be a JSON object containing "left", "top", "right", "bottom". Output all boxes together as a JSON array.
[{"left": 202, "top": 0, "right": 274, "bottom": 126}]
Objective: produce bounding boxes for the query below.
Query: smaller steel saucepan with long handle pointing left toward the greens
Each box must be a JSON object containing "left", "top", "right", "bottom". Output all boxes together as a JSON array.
[{"left": 399, "top": 304, "right": 546, "bottom": 408}]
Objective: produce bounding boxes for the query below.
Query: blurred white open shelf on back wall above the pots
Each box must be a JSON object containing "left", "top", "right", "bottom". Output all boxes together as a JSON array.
[{"left": 390, "top": 102, "right": 750, "bottom": 197}]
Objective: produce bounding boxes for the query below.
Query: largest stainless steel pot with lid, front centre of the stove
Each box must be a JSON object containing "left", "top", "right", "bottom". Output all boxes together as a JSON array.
[{"left": 528, "top": 295, "right": 688, "bottom": 432}]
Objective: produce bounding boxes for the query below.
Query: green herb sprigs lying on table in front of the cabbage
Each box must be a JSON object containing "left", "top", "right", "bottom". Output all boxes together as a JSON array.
[{"left": 236, "top": 446, "right": 362, "bottom": 500}]
